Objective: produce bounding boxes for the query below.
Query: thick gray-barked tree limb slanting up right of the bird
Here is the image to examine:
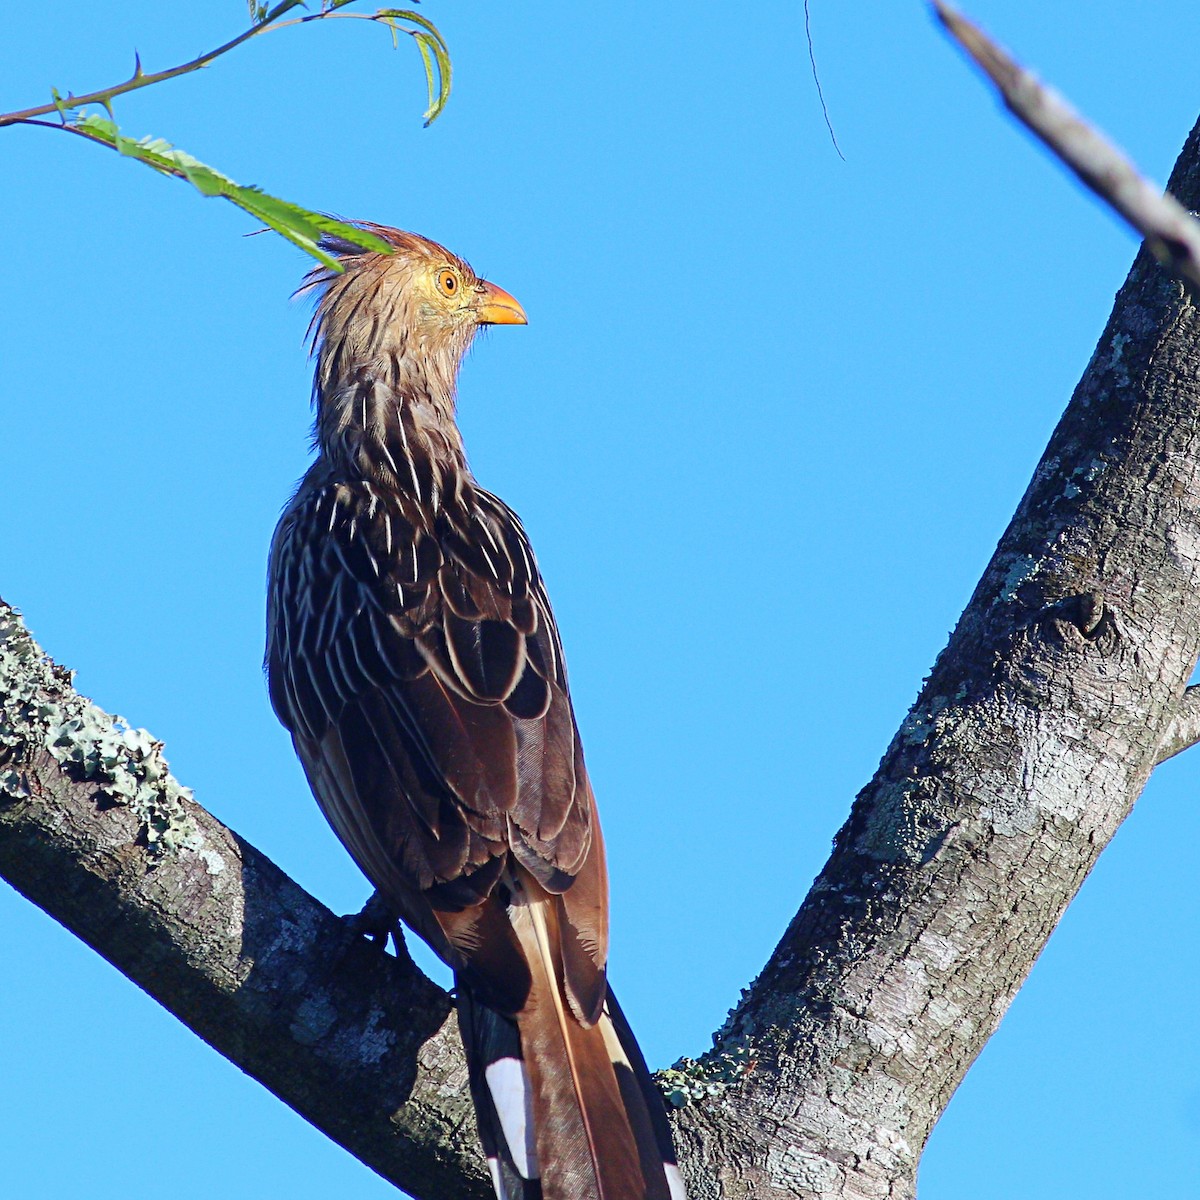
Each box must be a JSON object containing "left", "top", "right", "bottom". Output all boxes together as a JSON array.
[{"left": 667, "top": 98, "right": 1200, "bottom": 1200}]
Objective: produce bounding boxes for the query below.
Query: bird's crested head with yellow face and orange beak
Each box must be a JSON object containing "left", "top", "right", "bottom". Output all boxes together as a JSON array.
[{"left": 301, "top": 223, "right": 526, "bottom": 397}]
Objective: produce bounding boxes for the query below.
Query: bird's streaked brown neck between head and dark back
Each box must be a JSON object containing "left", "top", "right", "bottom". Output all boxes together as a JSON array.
[{"left": 314, "top": 359, "right": 469, "bottom": 511}]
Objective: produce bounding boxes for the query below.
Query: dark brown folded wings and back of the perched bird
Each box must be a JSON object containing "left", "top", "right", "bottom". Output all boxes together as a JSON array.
[{"left": 268, "top": 481, "right": 607, "bottom": 1019}]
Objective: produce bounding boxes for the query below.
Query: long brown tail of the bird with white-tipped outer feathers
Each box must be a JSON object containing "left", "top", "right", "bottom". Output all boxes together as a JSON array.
[{"left": 458, "top": 888, "right": 686, "bottom": 1200}]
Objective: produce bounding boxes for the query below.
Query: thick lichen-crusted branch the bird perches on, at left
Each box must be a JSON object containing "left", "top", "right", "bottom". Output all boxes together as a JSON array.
[{"left": 0, "top": 602, "right": 491, "bottom": 1200}]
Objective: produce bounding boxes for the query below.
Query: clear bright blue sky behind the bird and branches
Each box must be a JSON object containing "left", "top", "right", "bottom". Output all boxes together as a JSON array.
[{"left": 0, "top": 0, "right": 1200, "bottom": 1200}]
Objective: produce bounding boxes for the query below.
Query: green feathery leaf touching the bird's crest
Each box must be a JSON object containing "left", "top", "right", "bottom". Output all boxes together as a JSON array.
[{"left": 68, "top": 113, "right": 391, "bottom": 271}]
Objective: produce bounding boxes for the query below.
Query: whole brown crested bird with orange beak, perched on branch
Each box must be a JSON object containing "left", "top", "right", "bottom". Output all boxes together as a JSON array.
[{"left": 265, "top": 222, "right": 686, "bottom": 1200}]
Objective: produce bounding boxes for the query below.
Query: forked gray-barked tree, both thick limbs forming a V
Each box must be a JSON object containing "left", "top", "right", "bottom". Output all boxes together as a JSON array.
[{"left": 0, "top": 110, "right": 1200, "bottom": 1200}]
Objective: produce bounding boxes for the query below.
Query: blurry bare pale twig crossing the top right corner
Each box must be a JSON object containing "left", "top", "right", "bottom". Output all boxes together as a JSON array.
[{"left": 932, "top": 0, "right": 1200, "bottom": 298}]
